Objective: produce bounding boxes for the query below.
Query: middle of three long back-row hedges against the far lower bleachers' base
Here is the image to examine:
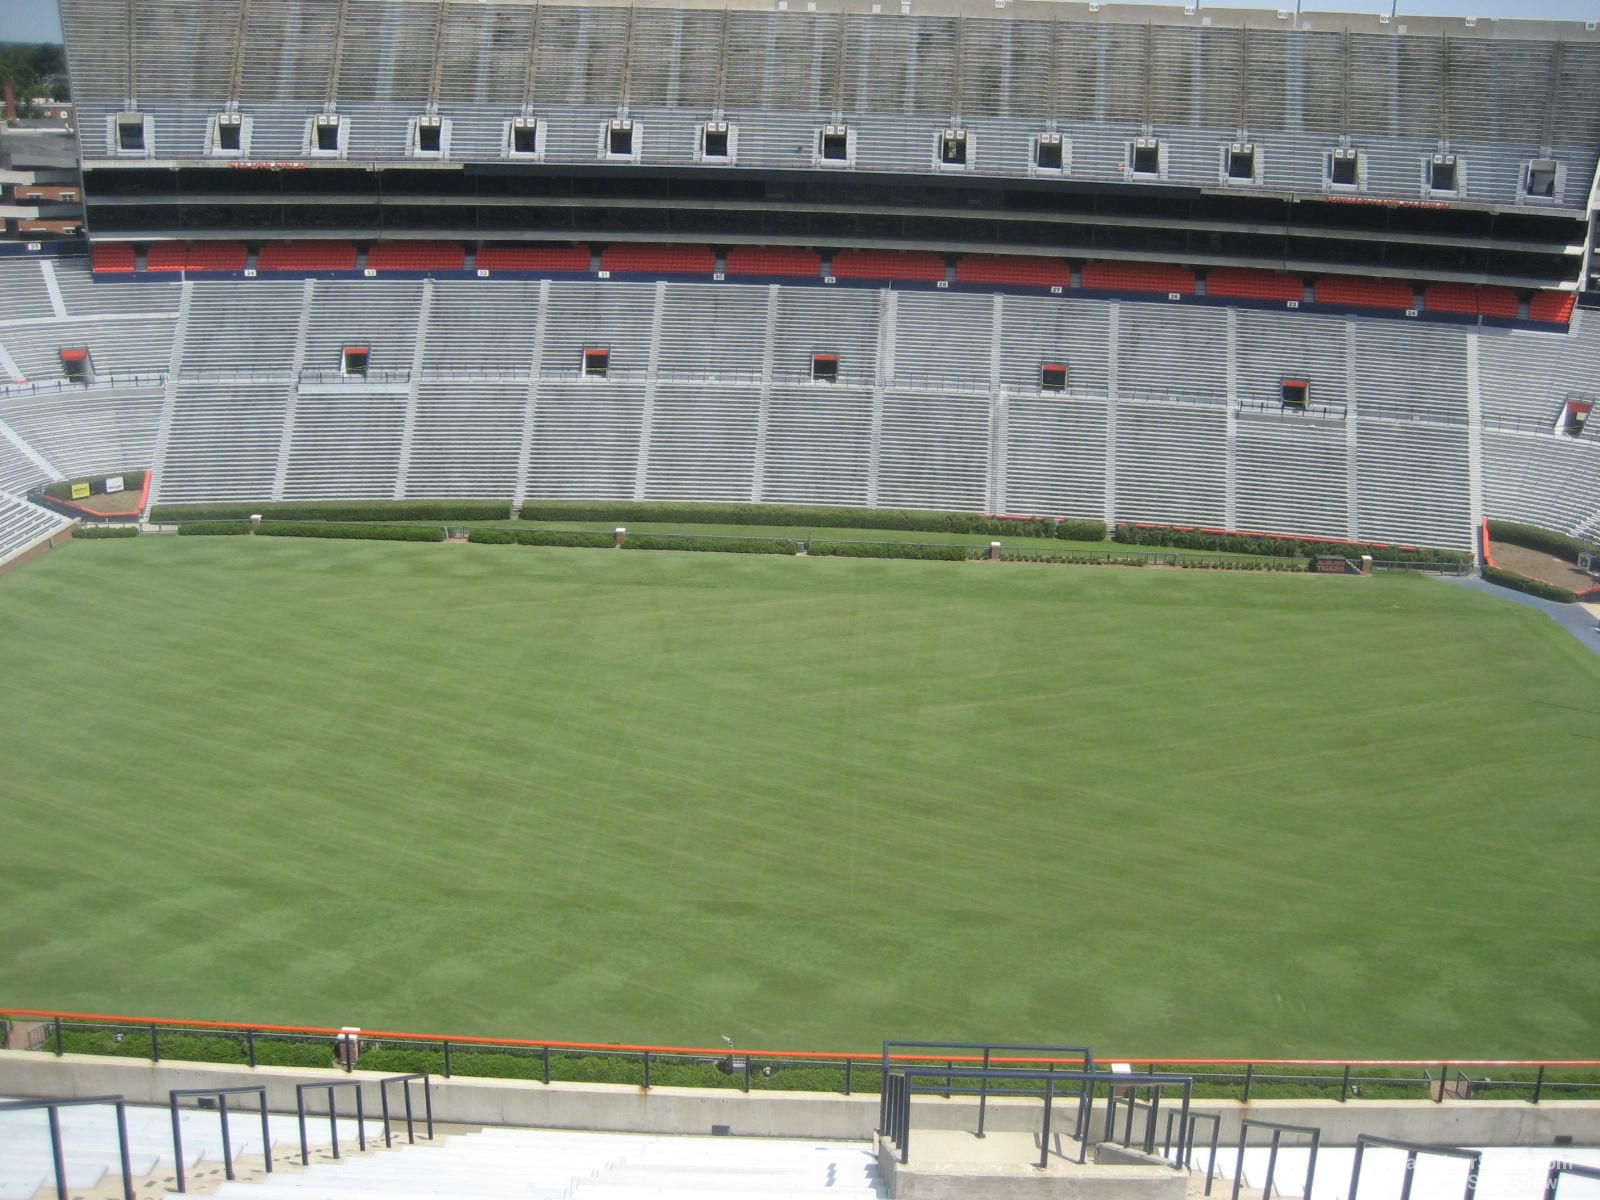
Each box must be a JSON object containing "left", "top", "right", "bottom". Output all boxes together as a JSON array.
[{"left": 522, "top": 501, "right": 1106, "bottom": 542}]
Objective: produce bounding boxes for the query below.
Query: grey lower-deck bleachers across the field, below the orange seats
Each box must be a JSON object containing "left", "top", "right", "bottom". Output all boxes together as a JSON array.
[{"left": 0, "top": 256, "right": 1600, "bottom": 547}]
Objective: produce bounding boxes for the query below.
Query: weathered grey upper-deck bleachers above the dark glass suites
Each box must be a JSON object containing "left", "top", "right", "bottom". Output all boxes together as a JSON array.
[{"left": 62, "top": 0, "right": 1600, "bottom": 206}]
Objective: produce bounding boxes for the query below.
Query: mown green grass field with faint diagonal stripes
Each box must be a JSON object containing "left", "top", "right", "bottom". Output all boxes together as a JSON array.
[{"left": 0, "top": 538, "right": 1600, "bottom": 1058}]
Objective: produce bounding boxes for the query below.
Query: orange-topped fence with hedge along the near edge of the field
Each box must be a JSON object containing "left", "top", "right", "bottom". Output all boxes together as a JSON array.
[{"left": 0, "top": 1008, "right": 1600, "bottom": 1107}]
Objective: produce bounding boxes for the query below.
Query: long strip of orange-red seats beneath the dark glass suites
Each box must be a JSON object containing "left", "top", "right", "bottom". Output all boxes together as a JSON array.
[{"left": 91, "top": 240, "right": 1574, "bottom": 325}]
